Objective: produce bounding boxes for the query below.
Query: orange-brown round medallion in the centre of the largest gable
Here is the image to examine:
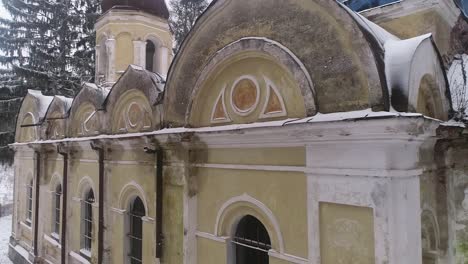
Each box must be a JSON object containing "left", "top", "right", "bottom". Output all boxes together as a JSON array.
[{"left": 231, "top": 76, "right": 260, "bottom": 115}]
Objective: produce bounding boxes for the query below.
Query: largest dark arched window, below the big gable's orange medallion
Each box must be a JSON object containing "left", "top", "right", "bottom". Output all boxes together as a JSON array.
[{"left": 232, "top": 215, "right": 271, "bottom": 264}]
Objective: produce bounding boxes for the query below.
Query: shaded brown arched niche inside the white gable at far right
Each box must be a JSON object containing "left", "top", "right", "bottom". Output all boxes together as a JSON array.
[{"left": 416, "top": 74, "right": 447, "bottom": 120}]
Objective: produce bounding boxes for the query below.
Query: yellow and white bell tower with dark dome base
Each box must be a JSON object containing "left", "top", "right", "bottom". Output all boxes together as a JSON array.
[{"left": 95, "top": 0, "right": 173, "bottom": 86}]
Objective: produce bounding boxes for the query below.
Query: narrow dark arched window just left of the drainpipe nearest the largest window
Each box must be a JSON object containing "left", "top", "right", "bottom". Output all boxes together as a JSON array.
[{"left": 127, "top": 197, "right": 146, "bottom": 264}]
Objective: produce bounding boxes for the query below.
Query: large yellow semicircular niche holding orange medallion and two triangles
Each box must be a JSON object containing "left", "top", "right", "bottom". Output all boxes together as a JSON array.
[{"left": 186, "top": 38, "right": 316, "bottom": 127}]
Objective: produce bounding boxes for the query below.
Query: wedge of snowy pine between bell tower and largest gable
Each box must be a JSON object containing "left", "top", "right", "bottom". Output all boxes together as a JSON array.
[{"left": 169, "top": 0, "right": 208, "bottom": 53}]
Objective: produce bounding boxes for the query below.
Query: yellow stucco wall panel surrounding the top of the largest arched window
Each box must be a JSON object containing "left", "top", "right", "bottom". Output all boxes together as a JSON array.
[{"left": 197, "top": 165, "right": 308, "bottom": 258}]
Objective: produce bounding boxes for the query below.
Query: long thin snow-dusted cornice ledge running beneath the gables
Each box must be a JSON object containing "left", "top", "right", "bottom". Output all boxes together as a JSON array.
[{"left": 9, "top": 109, "right": 441, "bottom": 147}]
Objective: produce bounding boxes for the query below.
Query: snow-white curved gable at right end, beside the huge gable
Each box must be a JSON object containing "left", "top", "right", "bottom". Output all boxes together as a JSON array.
[{"left": 386, "top": 34, "right": 452, "bottom": 120}]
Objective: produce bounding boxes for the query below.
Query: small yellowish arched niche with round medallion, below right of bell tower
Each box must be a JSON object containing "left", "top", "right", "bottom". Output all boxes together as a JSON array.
[{"left": 111, "top": 89, "right": 153, "bottom": 133}]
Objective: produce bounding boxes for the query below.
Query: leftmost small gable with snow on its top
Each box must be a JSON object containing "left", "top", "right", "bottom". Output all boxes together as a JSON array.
[{"left": 15, "top": 90, "right": 53, "bottom": 142}]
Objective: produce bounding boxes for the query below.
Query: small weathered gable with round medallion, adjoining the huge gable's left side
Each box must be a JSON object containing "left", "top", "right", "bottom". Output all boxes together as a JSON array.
[{"left": 104, "top": 65, "right": 165, "bottom": 133}]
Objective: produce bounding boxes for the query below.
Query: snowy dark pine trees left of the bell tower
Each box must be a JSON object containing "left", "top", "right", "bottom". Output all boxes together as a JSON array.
[{"left": 0, "top": 0, "right": 99, "bottom": 96}]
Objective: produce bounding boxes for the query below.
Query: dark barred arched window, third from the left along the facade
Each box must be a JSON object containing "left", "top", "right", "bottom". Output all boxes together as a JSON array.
[{"left": 81, "top": 189, "right": 94, "bottom": 259}]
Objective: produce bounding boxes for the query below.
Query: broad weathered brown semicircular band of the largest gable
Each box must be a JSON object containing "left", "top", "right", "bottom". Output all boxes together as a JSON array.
[{"left": 164, "top": 0, "right": 388, "bottom": 126}]
